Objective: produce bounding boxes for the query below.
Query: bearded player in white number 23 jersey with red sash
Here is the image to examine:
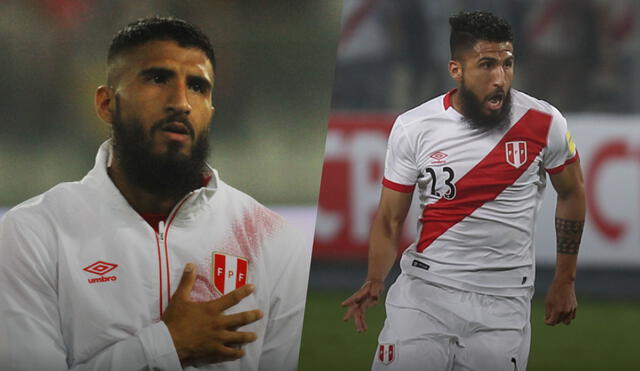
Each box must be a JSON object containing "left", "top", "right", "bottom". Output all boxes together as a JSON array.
[{"left": 343, "top": 12, "right": 585, "bottom": 371}]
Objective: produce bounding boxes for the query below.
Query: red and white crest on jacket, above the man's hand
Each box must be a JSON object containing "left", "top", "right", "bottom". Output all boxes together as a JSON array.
[{"left": 211, "top": 252, "right": 249, "bottom": 295}]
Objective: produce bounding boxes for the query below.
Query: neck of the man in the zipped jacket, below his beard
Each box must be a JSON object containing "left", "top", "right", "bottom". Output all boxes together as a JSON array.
[{"left": 107, "top": 158, "right": 181, "bottom": 214}]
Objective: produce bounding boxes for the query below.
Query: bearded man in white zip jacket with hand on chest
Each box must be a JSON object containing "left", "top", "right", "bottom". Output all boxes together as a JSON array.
[{"left": 0, "top": 17, "right": 310, "bottom": 371}]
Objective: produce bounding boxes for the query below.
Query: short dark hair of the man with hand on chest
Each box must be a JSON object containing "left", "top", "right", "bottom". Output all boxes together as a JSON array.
[{"left": 107, "top": 16, "right": 216, "bottom": 72}]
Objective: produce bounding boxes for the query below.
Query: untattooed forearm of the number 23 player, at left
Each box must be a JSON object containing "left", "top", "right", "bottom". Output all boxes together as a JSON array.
[{"left": 367, "top": 214, "right": 402, "bottom": 281}]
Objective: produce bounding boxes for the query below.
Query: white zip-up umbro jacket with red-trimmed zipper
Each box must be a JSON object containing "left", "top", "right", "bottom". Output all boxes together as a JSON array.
[{"left": 0, "top": 143, "right": 310, "bottom": 371}]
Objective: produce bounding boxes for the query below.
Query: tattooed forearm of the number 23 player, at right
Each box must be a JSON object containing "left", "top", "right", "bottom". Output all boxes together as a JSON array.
[{"left": 555, "top": 186, "right": 585, "bottom": 282}]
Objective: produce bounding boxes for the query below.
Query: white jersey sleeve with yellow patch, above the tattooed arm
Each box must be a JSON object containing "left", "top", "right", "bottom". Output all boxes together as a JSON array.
[{"left": 543, "top": 108, "right": 578, "bottom": 174}]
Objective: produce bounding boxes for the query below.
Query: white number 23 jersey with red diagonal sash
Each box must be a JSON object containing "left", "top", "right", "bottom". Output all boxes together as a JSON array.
[{"left": 383, "top": 89, "right": 578, "bottom": 296}]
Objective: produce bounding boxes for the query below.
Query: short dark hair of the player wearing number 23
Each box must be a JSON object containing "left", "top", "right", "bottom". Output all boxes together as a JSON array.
[{"left": 449, "top": 11, "right": 513, "bottom": 60}]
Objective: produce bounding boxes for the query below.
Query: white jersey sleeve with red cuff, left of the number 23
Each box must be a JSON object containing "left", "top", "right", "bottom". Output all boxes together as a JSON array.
[{"left": 382, "top": 117, "right": 419, "bottom": 193}]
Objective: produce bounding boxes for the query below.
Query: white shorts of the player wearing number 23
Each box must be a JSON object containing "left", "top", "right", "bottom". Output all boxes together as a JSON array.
[{"left": 372, "top": 274, "right": 531, "bottom": 371}]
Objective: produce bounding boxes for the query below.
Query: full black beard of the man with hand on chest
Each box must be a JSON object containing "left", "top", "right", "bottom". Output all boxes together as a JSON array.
[{"left": 112, "top": 97, "right": 209, "bottom": 199}]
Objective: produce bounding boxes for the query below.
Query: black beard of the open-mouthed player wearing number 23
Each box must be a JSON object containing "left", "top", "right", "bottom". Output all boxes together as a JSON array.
[{"left": 458, "top": 82, "right": 511, "bottom": 132}]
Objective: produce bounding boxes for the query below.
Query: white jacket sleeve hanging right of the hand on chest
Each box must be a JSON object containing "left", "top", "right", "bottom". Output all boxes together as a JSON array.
[{"left": 259, "top": 225, "right": 311, "bottom": 371}]
